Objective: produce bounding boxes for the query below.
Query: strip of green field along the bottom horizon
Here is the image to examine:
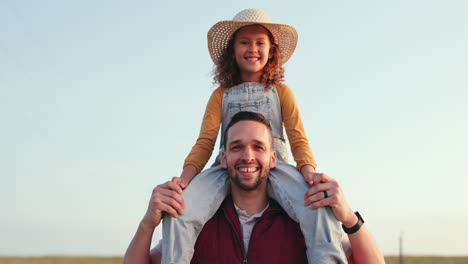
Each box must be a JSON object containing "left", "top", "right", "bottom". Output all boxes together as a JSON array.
[{"left": 0, "top": 256, "right": 468, "bottom": 264}]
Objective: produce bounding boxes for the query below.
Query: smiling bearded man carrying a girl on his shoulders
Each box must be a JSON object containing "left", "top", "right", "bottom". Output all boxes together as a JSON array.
[{"left": 124, "top": 112, "right": 384, "bottom": 264}]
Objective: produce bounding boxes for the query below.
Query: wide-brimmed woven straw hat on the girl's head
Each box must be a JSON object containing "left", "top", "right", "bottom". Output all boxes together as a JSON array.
[{"left": 208, "top": 8, "right": 297, "bottom": 64}]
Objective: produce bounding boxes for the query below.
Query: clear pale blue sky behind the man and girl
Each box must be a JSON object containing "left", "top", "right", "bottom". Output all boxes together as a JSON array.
[{"left": 0, "top": 0, "right": 468, "bottom": 256}]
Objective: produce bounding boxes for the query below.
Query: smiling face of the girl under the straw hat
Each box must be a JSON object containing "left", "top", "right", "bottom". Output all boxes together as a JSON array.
[{"left": 234, "top": 25, "right": 272, "bottom": 82}]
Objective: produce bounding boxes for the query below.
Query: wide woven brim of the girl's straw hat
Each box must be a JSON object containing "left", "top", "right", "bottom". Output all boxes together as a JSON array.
[{"left": 208, "top": 20, "right": 297, "bottom": 64}]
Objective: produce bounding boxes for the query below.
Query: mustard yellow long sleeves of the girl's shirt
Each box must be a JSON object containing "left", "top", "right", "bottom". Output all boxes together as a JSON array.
[{"left": 184, "top": 84, "right": 317, "bottom": 172}]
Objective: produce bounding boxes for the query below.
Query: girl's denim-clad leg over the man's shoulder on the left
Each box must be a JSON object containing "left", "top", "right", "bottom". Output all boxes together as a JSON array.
[{"left": 161, "top": 166, "right": 229, "bottom": 264}]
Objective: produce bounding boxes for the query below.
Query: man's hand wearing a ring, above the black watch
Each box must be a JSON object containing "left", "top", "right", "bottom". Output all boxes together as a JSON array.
[{"left": 304, "top": 173, "right": 358, "bottom": 227}]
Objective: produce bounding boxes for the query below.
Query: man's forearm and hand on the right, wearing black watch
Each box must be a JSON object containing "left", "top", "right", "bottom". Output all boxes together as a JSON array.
[{"left": 304, "top": 173, "right": 385, "bottom": 264}]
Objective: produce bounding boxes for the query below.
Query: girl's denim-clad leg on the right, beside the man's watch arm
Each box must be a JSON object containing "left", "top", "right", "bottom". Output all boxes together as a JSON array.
[{"left": 268, "top": 162, "right": 347, "bottom": 264}]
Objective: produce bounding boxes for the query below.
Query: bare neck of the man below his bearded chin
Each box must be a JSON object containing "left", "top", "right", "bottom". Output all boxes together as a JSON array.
[{"left": 231, "top": 185, "right": 268, "bottom": 215}]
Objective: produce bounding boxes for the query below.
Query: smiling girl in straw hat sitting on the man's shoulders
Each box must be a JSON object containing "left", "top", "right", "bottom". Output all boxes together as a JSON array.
[{"left": 162, "top": 9, "right": 346, "bottom": 263}]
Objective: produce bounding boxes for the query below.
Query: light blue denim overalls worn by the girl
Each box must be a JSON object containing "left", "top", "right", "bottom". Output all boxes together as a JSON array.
[{"left": 161, "top": 83, "right": 347, "bottom": 264}]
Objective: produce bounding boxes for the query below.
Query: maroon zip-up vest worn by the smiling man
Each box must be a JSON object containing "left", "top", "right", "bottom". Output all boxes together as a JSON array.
[{"left": 191, "top": 198, "right": 307, "bottom": 264}]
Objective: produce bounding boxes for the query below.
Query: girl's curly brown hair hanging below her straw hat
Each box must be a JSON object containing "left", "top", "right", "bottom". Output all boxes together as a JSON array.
[{"left": 213, "top": 25, "right": 284, "bottom": 89}]
